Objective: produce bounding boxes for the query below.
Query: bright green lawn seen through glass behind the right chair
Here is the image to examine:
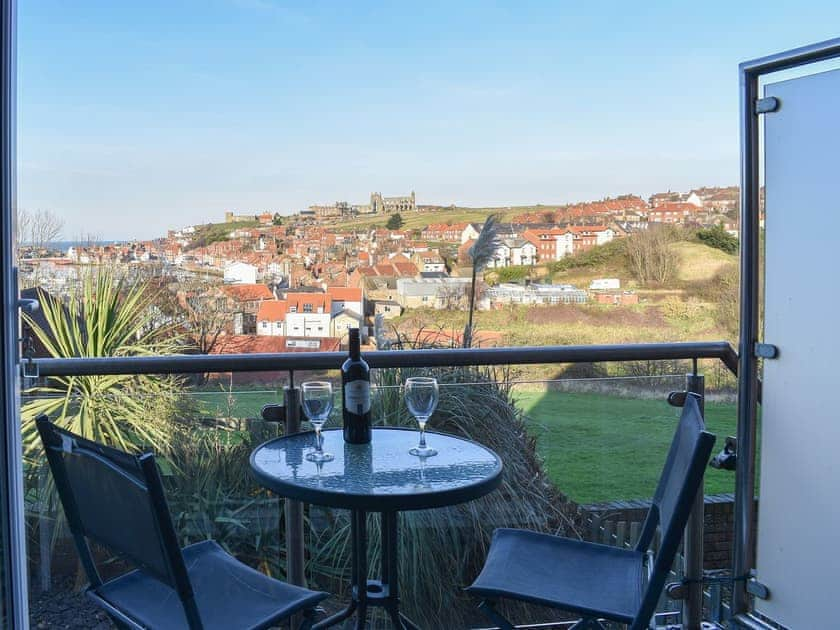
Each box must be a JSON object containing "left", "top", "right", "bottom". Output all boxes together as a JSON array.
[{"left": 514, "top": 392, "right": 736, "bottom": 503}]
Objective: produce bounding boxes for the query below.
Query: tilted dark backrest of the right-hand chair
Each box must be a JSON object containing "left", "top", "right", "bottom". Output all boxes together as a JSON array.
[{"left": 631, "top": 393, "right": 715, "bottom": 630}]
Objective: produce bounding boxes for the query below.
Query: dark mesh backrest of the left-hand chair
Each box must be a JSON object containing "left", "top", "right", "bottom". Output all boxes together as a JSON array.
[{"left": 36, "top": 415, "right": 201, "bottom": 628}]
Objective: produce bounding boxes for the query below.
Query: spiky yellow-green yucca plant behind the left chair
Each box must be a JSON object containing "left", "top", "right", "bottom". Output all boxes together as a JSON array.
[{"left": 22, "top": 268, "right": 185, "bottom": 457}]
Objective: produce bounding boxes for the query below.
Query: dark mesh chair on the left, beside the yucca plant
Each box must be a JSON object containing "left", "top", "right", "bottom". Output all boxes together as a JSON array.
[{"left": 37, "top": 416, "right": 328, "bottom": 630}]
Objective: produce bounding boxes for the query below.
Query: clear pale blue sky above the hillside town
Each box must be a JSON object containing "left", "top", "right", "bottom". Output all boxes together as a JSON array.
[{"left": 18, "top": 0, "right": 840, "bottom": 240}]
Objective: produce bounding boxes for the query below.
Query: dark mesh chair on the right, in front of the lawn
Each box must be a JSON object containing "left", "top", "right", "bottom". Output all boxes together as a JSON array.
[{"left": 467, "top": 394, "right": 715, "bottom": 630}]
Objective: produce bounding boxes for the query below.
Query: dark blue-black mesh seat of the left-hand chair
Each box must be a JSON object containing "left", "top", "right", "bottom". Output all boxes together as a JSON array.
[{"left": 90, "top": 540, "right": 324, "bottom": 630}]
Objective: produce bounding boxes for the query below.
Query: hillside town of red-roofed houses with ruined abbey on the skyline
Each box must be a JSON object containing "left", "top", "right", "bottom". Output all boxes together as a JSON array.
[{"left": 21, "top": 187, "right": 738, "bottom": 353}]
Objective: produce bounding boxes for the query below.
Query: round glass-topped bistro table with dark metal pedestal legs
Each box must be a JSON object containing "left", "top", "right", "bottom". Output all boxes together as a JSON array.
[{"left": 251, "top": 427, "right": 502, "bottom": 629}]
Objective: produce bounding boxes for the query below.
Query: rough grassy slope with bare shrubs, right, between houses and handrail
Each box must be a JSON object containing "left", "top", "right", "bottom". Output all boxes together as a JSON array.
[{"left": 392, "top": 236, "right": 737, "bottom": 376}]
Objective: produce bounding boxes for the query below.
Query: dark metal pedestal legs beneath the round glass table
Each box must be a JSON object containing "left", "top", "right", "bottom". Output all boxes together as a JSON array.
[{"left": 313, "top": 510, "right": 419, "bottom": 630}]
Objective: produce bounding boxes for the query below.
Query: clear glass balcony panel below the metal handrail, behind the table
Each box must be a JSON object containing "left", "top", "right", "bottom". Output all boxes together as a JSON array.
[{"left": 24, "top": 362, "right": 735, "bottom": 627}]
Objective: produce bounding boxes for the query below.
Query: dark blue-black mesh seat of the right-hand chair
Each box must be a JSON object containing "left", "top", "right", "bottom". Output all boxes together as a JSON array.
[{"left": 467, "top": 529, "right": 645, "bottom": 623}]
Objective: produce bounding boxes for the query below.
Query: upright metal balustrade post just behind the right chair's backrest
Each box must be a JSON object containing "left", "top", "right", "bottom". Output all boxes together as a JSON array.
[{"left": 682, "top": 372, "right": 705, "bottom": 630}]
